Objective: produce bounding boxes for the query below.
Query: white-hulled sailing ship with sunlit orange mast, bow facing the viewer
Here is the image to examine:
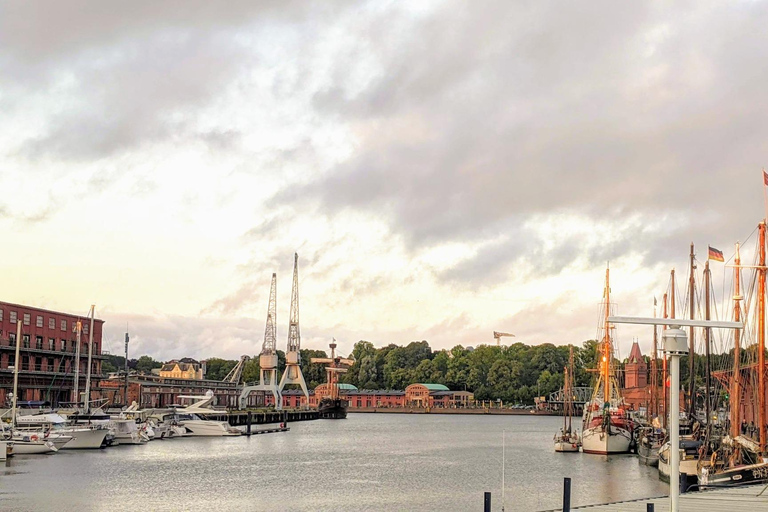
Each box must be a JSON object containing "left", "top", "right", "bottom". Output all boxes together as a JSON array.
[{"left": 581, "top": 269, "right": 634, "bottom": 455}]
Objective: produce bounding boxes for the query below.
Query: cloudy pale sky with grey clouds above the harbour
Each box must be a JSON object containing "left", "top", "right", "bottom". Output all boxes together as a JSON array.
[{"left": 0, "top": 0, "right": 768, "bottom": 360}]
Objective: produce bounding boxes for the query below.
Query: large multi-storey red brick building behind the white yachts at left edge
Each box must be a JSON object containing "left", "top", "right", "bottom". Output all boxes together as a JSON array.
[{"left": 0, "top": 302, "right": 105, "bottom": 406}]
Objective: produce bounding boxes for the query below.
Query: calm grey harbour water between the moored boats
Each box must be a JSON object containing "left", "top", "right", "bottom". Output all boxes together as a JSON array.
[{"left": 0, "top": 414, "right": 666, "bottom": 512}]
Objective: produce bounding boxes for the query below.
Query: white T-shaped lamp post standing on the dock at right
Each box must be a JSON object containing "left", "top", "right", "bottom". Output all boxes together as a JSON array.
[{"left": 608, "top": 316, "right": 744, "bottom": 512}]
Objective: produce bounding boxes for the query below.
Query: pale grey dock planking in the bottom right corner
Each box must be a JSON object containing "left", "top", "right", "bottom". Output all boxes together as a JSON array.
[{"left": 548, "top": 485, "right": 768, "bottom": 512}]
